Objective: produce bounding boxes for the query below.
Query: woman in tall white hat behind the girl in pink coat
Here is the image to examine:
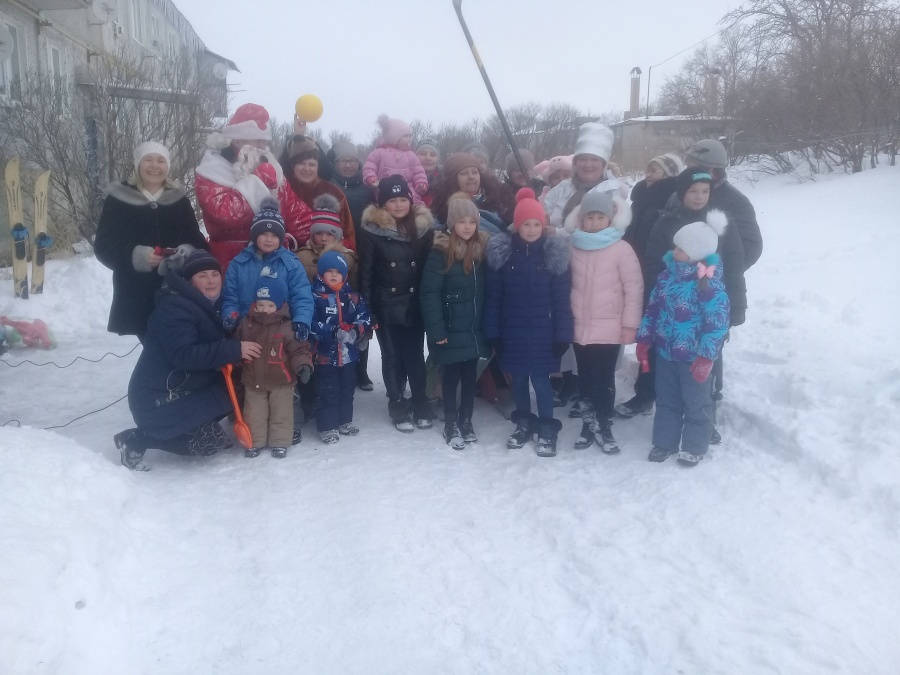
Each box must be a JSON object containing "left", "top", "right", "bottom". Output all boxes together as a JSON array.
[{"left": 544, "top": 122, "right": 619, "bottom": 231}]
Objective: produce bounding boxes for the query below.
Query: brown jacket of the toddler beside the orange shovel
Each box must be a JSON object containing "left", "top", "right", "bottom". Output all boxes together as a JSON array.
[{"left": 237, "top": 303, "right": 312, "bottom": 392}]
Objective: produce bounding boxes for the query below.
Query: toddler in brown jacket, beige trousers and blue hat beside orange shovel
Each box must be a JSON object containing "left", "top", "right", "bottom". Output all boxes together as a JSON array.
[{"left": 237, "top": 277, "right": 312, "bottom": 458}]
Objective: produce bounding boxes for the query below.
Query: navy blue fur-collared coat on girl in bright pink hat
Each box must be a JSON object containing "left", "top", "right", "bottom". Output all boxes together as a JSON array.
[{"left": 483, "top": 233, "right": 575, "bottom": 375}]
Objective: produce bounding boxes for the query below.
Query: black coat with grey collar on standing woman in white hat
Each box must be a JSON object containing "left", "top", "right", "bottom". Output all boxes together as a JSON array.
[{"left": 94, "top": 183, "right": 209, "bottom": 335}]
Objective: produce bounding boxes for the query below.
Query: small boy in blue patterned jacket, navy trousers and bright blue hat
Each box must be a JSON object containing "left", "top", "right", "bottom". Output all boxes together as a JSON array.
[{"left": 312, "top": 251, "right": 372, "bottom": 444}]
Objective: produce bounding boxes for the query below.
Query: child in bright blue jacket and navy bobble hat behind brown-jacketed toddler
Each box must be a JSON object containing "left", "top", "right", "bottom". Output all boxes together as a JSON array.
[{"left": 222, "top": 199, "right": 313, "bottom": 342}]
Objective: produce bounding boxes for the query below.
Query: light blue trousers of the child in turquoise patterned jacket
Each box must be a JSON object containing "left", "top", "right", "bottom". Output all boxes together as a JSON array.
[{"left": 653, "top": 354, "right": 713, "bottom": 457}]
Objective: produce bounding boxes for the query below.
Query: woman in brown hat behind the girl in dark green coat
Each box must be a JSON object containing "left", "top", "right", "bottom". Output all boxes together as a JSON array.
[{"left": 431, "top": 153, "right": 516, "bottom": 234}]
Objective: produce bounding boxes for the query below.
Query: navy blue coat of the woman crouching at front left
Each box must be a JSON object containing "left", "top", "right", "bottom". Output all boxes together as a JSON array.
[{"left": 128, "top": 272, "right": 241, "bottom": 440}]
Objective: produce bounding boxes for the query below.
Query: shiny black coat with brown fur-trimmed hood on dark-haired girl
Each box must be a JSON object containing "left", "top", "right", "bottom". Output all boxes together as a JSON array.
[{"left": 359, "top": 204, "right": 434, "bottom": 328}]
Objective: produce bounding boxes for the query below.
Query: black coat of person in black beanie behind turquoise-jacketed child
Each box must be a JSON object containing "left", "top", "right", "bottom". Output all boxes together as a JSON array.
[{"left": 642, "top": 206, "right": 747, "bottom": 313}]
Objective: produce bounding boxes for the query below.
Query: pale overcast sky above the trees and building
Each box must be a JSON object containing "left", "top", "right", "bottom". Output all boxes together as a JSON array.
[{"left": 175, "top": 0, "right": 739, "bottom": 143}]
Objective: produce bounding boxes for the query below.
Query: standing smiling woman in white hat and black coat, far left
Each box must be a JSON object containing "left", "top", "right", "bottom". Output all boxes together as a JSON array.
[{"left": 94, "top": 141, "right": 208, "bottom": 341}]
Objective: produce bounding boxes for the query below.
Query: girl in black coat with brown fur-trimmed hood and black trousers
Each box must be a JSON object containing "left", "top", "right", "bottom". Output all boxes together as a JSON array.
[{"left": 359, "top": 176, "right": 434, "bottom": 432}]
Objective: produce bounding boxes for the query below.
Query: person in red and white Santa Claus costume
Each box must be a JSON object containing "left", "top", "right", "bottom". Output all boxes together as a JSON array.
[{"left": 194, "top": 103, "right": 312, "bottom": 270}]
